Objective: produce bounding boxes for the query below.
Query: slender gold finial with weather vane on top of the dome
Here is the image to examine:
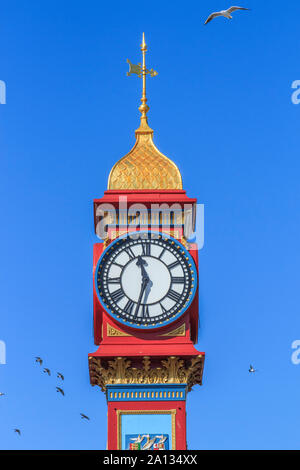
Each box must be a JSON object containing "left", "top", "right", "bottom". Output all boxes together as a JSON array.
[{"left": 127, "top": 33, "right": 158, "bottom": 133}]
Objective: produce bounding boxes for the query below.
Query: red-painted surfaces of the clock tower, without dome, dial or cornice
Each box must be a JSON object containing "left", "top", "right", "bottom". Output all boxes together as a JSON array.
[{"left": 89, "top": 190, "right": 204, "bottom": 449}]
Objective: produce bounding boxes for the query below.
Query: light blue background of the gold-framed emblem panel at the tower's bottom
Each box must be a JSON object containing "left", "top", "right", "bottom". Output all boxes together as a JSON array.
[{"left": 121, "top": 411, "right": 172, "bottom": 450}]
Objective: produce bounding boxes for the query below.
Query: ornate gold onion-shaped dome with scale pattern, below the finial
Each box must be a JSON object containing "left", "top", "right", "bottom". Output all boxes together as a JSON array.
[{"left": 108, "top": 121, "right": 182, "bottom": 190}]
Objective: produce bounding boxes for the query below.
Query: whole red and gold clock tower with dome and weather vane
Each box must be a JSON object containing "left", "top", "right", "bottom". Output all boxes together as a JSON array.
[{"left": 89, "top": 35, "right": 204, "bottom": 450}]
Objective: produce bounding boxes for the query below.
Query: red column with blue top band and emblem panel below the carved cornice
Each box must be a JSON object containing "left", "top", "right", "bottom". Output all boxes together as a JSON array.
[{"left": 107, "top": 384, "right": 186, "bottom": 450}]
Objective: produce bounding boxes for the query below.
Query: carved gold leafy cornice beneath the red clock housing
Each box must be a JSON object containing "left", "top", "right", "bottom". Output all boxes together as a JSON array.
[{"left": 89, "top": 355, "right": 204, "bottom": 391}]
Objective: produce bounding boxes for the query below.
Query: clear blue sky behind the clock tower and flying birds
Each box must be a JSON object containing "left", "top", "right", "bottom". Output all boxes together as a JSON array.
[{"left": 0, "top": 0, "right": 300, "bottom": 449}]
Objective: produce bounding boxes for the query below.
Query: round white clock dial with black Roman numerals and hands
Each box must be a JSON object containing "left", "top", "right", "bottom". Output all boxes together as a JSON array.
[{"left": 96, "top": 233, "right": 195, "bottom": 327}]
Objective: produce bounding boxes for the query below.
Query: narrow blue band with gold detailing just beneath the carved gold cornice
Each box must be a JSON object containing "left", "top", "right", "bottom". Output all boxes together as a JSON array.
[{"left": 106, "top": 384, "right": 186, "bottom": 401}]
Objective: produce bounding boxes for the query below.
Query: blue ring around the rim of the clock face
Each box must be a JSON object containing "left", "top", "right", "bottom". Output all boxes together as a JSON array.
[{"left": 94, "top": 230, "right": 198, "bottom": 331}]
